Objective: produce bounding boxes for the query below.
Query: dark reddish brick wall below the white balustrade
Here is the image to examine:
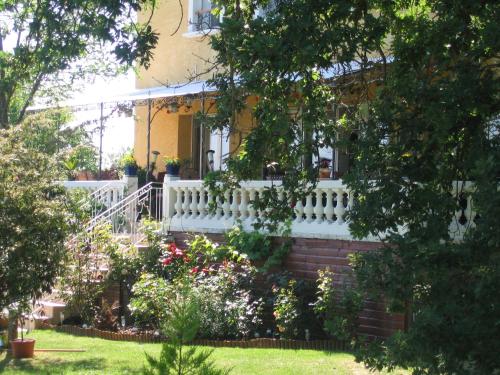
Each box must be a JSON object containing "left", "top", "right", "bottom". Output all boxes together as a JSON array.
[{"left": 174, "top": 232, "right": 404, "bottom": 337}]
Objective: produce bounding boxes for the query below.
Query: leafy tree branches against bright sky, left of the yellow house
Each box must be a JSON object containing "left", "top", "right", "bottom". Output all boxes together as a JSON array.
[{"left": 0, "top": 0, "right": 157, "bottom": 128}]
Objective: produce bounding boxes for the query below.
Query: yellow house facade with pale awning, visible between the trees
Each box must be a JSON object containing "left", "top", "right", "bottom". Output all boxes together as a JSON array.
[{"left": 134, "top": 0, "right": 258, "bottom": 179}]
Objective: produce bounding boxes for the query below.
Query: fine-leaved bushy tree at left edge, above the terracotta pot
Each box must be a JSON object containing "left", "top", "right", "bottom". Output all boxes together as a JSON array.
[{"left": 0, "top": 122, "right": 74, "bottom": 307}]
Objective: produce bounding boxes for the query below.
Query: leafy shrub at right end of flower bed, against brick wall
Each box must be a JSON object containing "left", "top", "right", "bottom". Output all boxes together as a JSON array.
[{"left": 313, "top": 268, "right": 363, "bottom": 341}]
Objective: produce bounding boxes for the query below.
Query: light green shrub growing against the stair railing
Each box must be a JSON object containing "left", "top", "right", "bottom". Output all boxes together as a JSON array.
[{"left": 59, "top": 225, "right": 118, "bottom": 325}]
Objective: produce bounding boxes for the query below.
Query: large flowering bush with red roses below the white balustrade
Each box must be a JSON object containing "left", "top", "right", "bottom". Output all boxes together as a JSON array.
[{"left": 127, "top": 232, "right": 262, "bottom": 338}]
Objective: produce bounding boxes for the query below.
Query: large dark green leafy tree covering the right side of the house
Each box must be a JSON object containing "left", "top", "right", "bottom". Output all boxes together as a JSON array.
[{"left": 207, "top": 0, "right": 500, "bottom": 374}]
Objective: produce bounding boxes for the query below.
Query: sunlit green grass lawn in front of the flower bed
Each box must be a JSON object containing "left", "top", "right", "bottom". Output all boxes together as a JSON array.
[{"left": 0, "top": 331, "right": 406, "bottom": 375}]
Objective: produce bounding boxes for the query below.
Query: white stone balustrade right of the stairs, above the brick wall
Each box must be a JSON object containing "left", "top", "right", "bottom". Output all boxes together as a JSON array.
[{"left": 163, "top": 177, "right": 353, "bottom": 239}]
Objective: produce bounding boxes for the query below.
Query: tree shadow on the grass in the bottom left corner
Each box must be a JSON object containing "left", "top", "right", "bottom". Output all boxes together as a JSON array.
[{"left": 0, "top": 352, "right": 142, "bottom": 375}]
